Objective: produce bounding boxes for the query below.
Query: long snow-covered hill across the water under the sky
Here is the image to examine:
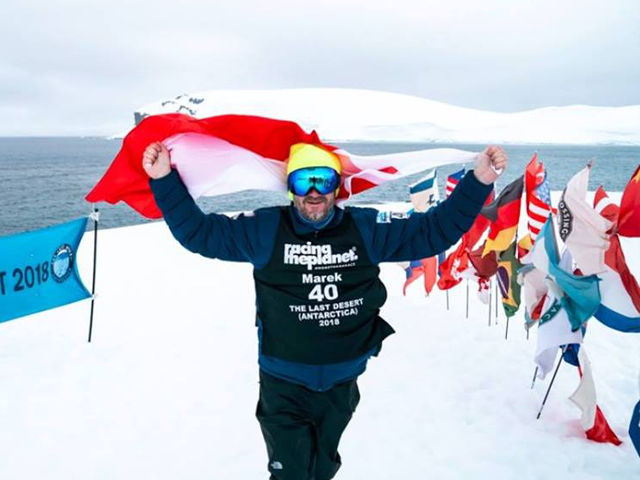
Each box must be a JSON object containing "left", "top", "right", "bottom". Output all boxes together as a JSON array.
[{"left": 135, "top": 88, "right": 640, "bottom": 145}]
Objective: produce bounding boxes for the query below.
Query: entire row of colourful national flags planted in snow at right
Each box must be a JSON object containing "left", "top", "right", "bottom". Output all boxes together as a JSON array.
[{"left": 404, "top": 158, "right": 640, "bottom": 454}]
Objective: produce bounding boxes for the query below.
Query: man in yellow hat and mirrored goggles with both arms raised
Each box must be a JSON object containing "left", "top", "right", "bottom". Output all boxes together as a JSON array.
[{"left": 142, "top": 142, "right": 507, "bottom": 480}]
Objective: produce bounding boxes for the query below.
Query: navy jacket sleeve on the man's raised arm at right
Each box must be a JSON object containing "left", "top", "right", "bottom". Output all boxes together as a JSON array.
[{"left": 352, "top": 170, "right": 493, "bottom": 263}]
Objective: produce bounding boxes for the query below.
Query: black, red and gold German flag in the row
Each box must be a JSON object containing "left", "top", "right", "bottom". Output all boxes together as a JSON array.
[{"left": 480, "top": 175, "right": 524, "bottom": 256}]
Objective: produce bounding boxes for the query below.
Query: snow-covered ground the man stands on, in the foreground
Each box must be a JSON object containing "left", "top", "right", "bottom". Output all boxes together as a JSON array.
[{"left": 0, "top": 208, "right": 640, "bottom": 480}]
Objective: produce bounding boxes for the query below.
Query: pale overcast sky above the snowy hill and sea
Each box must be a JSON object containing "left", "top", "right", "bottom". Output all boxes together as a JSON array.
[{"left": 0, "top": 0, "right": 640, "bottom": 136}]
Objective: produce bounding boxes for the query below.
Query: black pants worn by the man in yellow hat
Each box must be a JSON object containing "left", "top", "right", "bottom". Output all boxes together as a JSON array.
[{"left": 256, "top": 371, "right": 360, "bottom": 480}]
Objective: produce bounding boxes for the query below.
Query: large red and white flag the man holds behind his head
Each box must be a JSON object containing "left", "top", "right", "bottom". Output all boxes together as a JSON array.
[{"left": 86, "top": 114, "right": 477, "bottom": 218}]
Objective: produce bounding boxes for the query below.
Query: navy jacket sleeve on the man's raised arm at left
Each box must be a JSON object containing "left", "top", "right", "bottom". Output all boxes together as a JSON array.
[{"left": 149, "top": 170, "right": 280, "bottom": 268}]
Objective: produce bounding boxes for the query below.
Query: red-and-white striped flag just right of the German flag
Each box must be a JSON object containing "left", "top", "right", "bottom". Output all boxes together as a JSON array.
[{"left": 525, "top": 153, "right": 551, "bottom": 244}]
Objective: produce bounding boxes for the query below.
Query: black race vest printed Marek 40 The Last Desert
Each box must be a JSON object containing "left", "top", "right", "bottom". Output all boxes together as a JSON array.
[{"left": 253, "top": 208, "right": 394, "bottom": 365}]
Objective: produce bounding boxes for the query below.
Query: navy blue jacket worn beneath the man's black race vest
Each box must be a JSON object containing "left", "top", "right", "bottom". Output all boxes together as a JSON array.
[{"left": 150, "top": 170, "right": 493, "bottom": 391}]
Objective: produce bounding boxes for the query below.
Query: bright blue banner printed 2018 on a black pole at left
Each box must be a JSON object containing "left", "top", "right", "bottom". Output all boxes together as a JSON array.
[{"left": 0, "top": 217, "right": 91, "bottom": 323}]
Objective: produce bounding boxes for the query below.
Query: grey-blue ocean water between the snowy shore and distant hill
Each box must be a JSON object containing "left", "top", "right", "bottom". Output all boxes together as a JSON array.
[{"left": 0, "top": 137, "right": 640, "bottom": 235}]
